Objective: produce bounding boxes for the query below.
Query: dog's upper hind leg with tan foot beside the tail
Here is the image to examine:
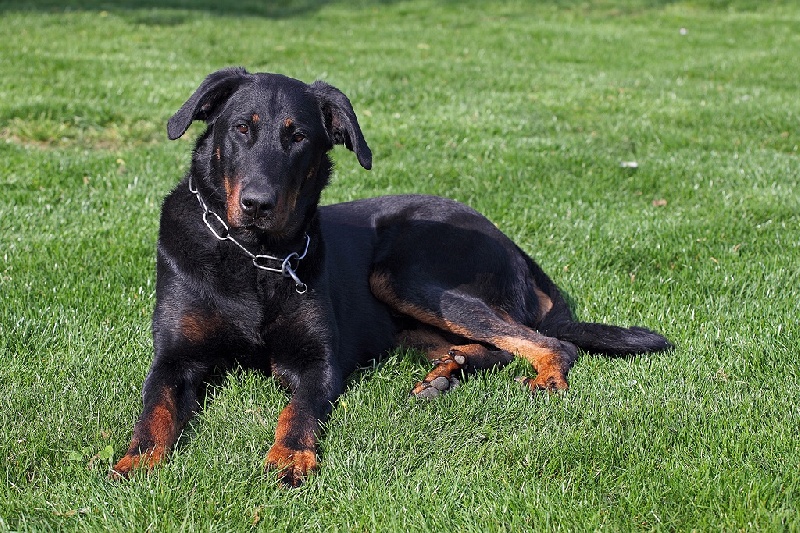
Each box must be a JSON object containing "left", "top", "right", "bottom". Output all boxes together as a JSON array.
[{"left": 370, "top": 273, "right": 578, "bottom": 391}]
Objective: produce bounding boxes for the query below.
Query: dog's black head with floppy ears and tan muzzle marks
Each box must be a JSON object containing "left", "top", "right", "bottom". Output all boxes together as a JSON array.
[{"left": 167, "top": 68, "right": 372, "bottom": 238}]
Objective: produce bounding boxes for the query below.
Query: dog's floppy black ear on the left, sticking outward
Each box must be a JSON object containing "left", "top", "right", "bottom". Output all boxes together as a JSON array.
[{"left": 167, "top": 67, "right": 249, "bottom": 141}]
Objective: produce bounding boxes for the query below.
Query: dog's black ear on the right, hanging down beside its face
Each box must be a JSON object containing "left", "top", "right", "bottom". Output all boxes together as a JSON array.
[{"left": 311, "top": 81, "right": 372, "bottom": 170}]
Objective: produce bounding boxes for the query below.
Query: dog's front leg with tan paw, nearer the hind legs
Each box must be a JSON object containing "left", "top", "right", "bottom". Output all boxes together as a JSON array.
[{"left": 264, "top": 358, "right": 342, "bottom": 487}]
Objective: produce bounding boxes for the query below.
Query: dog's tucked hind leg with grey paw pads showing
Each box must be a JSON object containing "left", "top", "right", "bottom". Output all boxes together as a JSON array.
[{"left": 398, "top": 329, "right": 514, "bottom": 398}]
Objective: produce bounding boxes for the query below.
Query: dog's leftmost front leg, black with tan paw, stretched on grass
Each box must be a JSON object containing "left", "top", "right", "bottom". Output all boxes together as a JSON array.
[{"left": 109, "top": 360, "right": 206, "bottom": 478}]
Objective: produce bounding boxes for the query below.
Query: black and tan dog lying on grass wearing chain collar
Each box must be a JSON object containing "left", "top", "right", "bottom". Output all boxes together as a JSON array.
[{"left": 109, "top": 68, "right": 672, "bottom": 487}]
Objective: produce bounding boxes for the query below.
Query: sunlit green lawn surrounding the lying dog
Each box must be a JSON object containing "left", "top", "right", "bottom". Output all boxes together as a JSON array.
[{"left": 0, "top": 0, "right": 800, "bottom": 531}]
